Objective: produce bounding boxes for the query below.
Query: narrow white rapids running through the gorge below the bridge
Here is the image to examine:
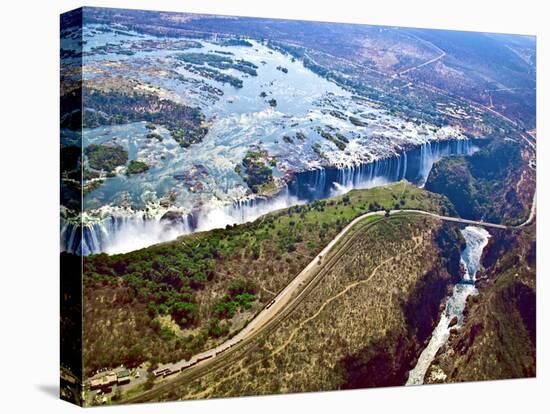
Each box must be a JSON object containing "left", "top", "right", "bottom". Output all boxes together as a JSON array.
[{"left": 407, "top": 226, "right": 491, "bottom": 385}]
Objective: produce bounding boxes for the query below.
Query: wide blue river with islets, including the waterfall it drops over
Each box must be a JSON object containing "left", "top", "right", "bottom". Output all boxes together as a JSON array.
[{"left": 60, "top": 25, "right": 477, "bottom": 255}]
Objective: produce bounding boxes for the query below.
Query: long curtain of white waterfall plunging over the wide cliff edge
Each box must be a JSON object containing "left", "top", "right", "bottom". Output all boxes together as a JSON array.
[{"left": 61, "top": 140, "right": 484, "bottom": 255}]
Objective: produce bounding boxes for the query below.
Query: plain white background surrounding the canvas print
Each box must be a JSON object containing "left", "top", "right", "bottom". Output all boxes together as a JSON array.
[{"left": 0, "top": 0, "right": 550, "bottom": 414}]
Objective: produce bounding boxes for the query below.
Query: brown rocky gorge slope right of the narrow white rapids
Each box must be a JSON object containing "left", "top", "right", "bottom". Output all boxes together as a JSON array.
[{"left": 426, "top": 228, "right": 536, "bottom": 383}]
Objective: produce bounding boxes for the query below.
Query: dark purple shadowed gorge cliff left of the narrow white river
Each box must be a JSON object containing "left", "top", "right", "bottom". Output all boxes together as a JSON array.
[{"left": 341, "top": 225, "right": 464, "bottom": 388}]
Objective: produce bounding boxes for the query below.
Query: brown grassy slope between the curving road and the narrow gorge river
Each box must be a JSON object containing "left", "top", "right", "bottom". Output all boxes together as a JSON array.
[{"left": 144, "top": 215, "right": 461, "bottom": 400}]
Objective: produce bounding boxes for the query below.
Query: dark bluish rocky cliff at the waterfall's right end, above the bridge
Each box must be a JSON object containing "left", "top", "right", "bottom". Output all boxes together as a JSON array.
[{"left": 426, "top": 140, "right": 534, "bottom": 224}]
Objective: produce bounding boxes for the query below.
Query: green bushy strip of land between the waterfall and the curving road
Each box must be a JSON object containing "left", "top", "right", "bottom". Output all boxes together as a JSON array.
[{"left": 83, "top": 182, "right": 451, "bottom": 374}]
